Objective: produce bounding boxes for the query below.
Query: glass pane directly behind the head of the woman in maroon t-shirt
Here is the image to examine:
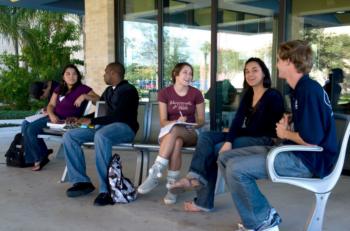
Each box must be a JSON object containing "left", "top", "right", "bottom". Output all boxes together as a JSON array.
[{"left": 163, "top": 0, "right": 211, "bottom": 91}]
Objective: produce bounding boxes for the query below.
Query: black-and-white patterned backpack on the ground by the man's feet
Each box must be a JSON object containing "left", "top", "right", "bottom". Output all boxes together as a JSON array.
[{"left": 108, "top": 154, "right": 137, "bottom": 203}]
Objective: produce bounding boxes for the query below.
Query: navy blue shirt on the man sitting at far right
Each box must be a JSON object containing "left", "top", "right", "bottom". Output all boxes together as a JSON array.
[{"left": 290, "top": 75, "right": 338, "bottom": 178}]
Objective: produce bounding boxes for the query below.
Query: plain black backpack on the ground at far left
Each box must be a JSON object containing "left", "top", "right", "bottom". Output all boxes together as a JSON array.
[{"left": 5, "top": 133, "right": 26, "bottom": 168}]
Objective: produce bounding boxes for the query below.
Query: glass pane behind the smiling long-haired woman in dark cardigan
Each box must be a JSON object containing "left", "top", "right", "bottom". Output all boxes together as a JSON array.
[{"left": 216, "top": 0, "right": 279, "bottom": 130}]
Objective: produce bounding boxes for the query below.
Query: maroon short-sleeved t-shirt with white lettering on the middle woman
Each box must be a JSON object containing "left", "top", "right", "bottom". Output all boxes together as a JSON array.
[{"left": 158, "top": 85, "right": 204, "bottom": 123}]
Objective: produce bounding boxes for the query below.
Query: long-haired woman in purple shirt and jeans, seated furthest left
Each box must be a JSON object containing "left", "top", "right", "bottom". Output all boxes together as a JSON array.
[{"left": 22, "top": 64, "right": 99, "bottom": 171}]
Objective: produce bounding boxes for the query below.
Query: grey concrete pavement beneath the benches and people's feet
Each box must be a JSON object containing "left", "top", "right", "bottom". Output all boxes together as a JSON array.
[{"left": 0, "top": 127, "right": 350, "bottom": 231}]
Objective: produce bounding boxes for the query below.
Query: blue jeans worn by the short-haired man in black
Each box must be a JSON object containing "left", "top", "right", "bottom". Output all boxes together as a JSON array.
[{"left": 63, "top": 122, "right": 135, "bottom": 193}]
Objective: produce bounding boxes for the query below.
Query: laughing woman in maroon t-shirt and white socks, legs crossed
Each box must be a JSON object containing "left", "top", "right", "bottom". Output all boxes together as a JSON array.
[{"left": 138, "top": 63, "right": 204, "bottom": 204}]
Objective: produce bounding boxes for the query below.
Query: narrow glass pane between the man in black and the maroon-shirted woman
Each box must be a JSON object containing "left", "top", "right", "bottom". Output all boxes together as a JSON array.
[{"left": 123, "top": 0, "right": 158, "bottom": 101}]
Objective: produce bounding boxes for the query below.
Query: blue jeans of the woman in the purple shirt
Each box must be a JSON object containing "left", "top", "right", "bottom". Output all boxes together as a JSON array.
[{"left": 21, "top": 117, "right": 49, "bottom": 164}]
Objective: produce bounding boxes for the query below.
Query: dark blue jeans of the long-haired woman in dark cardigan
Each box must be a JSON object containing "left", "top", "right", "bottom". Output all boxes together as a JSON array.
[{"left": 187, "top": 131, "right": 273, "bottom": 210}]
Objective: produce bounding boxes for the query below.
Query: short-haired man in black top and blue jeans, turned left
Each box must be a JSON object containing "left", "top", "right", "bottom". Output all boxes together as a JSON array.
[{"left": 63, "top": 62, "right": 139, "bottom": 206}]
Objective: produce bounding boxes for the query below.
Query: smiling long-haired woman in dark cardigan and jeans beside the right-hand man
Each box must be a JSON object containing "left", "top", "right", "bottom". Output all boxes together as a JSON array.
[{"left": 168, "top": 58, "right": 284, "bottom": 212}]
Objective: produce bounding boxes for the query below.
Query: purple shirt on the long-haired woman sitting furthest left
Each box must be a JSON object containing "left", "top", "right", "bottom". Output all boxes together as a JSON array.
[{"left": 54, "top": 84, "right": 91, "bottom": 119}]
